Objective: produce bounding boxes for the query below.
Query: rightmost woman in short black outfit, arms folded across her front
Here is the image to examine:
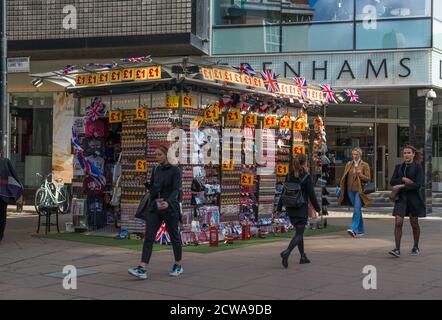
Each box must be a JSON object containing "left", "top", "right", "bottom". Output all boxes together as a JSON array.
[{"left": 389, "top": 146, "right": 426, "bottom": 258}]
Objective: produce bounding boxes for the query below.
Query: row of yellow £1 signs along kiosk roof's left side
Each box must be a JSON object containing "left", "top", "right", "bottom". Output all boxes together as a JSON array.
[{"left": 75, "top": 66, "right": 161, "bottom": 87}]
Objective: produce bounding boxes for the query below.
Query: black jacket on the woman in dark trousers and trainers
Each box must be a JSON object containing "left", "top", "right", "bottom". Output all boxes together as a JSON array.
[{"left": 147, "top": 165, "right": 182, "bottom": 214}]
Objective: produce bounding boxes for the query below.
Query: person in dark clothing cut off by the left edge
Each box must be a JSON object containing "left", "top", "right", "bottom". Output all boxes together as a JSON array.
[{"left": 0, "top": 157, "right": 23, "bottom": 242}]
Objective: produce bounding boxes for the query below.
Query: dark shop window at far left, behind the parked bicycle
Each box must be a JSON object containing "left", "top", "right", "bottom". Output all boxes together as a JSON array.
[{"left": 10, "top": 94, "right": 54, "bottom": 188}]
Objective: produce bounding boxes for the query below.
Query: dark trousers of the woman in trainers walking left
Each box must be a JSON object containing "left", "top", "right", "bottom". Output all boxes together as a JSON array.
[{"left": 141, "top": 210, "right": 183, "bottom": 264}]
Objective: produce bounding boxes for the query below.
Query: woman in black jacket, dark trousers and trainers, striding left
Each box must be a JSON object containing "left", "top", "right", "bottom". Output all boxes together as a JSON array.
[{"left": 129, "top": 146, "right": 184, "bottom": 280}]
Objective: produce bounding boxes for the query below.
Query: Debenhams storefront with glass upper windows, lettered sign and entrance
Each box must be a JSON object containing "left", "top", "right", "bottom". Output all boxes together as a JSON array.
[{"left": 212, "top": 0, "right": 442, "bottom": 196}]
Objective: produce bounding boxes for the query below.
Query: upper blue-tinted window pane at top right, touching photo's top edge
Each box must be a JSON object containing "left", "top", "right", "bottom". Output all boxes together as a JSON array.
[{"left": 356, "top": 0, "right": 432, "bottom": 20}]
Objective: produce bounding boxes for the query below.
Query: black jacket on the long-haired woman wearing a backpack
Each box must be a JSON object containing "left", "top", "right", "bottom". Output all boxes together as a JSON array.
[{"left": 278, "top": 172, "right": 321, "bottom": 219}]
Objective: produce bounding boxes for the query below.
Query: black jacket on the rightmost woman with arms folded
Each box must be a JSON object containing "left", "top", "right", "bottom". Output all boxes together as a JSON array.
[{"left": 390, "top": 162, "right": 426, "bottom": 217}]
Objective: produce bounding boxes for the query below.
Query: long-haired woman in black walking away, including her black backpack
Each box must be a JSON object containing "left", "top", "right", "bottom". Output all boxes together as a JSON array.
[{"left": 277, "top": 154, "right": 321, "bottom": 269}]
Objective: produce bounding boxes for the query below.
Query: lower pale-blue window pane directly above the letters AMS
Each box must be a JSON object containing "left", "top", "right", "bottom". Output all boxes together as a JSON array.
[{"left": 356, "top": 19, "right": 431, "bottom": 50}]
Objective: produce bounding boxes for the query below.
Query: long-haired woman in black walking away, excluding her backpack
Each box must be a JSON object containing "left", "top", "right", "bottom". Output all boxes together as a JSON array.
[{"left": 277, "top": 154, "right": 321, "bottom": 269}]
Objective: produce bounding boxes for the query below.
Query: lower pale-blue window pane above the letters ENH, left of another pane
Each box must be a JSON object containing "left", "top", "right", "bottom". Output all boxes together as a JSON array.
[{"left": 282, "top": 23, "right": 353, "bottom": 52}]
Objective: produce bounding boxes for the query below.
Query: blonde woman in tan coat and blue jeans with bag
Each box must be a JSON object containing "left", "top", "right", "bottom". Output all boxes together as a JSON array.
[{"left": 338, "top": 148, "right": 374, "bottom": 238}]
